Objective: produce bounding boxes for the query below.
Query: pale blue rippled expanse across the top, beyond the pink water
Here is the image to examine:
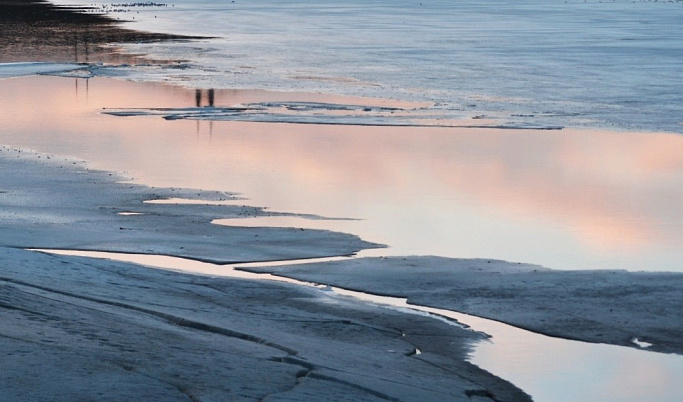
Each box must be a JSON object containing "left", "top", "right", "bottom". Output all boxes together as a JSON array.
[{"left": 54, "top": 0, "right": 683, "bottom": 133}]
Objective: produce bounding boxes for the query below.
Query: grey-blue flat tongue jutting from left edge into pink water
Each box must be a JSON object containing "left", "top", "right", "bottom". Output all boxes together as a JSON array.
[{"left": 0, "top": 146, "right": 378, "bottom": 264}]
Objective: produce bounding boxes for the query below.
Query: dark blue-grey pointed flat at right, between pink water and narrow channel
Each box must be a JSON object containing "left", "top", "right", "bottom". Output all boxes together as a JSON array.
[{"left": 245, "top": 257, "right": 683, "bottom": 354}]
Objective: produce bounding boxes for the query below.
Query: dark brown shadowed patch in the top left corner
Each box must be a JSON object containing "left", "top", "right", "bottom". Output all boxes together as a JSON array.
[{"left": 0, "top": 0, "right": 198, "bottom": 64}]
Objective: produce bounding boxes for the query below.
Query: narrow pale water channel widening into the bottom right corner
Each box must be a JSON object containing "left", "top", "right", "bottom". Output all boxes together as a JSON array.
[{"left": 37, "top": 250, "right": 683, "bottom": 402}]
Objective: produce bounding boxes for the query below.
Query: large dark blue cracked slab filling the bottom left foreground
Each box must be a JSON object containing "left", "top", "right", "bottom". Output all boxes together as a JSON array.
[{"left": 0, "top": 247, "right": 530, "bottom": 401}]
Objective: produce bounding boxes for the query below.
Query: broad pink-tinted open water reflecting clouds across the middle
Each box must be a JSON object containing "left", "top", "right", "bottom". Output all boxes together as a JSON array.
[{"left": 0, "top": 73, "right": 683, "bottom": 272}]
